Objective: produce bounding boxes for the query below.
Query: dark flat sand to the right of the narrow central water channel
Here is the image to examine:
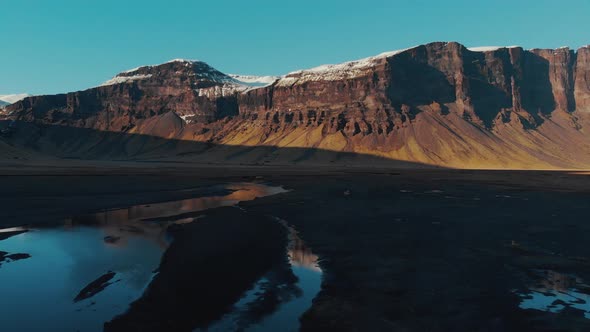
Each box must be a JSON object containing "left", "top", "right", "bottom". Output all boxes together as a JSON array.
[{"left": 243, "top": 173, "right": 590, "bottom": 331}]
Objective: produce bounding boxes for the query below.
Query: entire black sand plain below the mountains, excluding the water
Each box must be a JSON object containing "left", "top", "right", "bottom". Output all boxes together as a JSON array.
[{"left": 0, "top": 163, "right": 590, "bottom": 331}]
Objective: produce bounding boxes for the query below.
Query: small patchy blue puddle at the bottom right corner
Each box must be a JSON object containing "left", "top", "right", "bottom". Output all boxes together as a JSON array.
[{"left": 518, "top": 270, "right": 590, "bottom": 319}]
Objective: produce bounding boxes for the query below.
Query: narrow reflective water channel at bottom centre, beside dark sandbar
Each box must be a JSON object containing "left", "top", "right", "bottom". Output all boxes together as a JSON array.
[{"left": 202, "top": 219, "right": 322, "bottom": 332}]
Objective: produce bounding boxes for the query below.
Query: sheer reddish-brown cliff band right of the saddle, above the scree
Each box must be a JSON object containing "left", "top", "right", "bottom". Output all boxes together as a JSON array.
[{"left": 240, "top": 43, "right": 590, "bottom": 133}]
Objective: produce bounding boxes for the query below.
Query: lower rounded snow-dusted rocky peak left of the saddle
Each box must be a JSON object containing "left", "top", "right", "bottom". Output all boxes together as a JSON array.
[{"left": 10, "top": 61, "right": 243, "bottom": 131}]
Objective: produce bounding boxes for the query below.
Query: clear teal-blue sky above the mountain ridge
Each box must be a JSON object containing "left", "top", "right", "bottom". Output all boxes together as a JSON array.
[{"left": 0, "top": 0, "right": 590, "bottom": 94}]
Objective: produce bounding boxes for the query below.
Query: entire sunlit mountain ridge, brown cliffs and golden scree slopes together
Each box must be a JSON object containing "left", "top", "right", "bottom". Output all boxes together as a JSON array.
[{"left": 7, "top": 43, "right": 590, "bottom": 168}]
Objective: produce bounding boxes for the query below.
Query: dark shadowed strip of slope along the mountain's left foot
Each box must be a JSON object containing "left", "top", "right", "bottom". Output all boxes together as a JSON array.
[{"left": 0, "top": 121, "right": 432, "bottom": 168}]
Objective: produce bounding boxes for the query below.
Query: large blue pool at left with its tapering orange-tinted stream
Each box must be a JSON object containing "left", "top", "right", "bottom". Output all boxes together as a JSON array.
[{"left": 0, "top": 183, "right": 292, "bottom": 331}]
